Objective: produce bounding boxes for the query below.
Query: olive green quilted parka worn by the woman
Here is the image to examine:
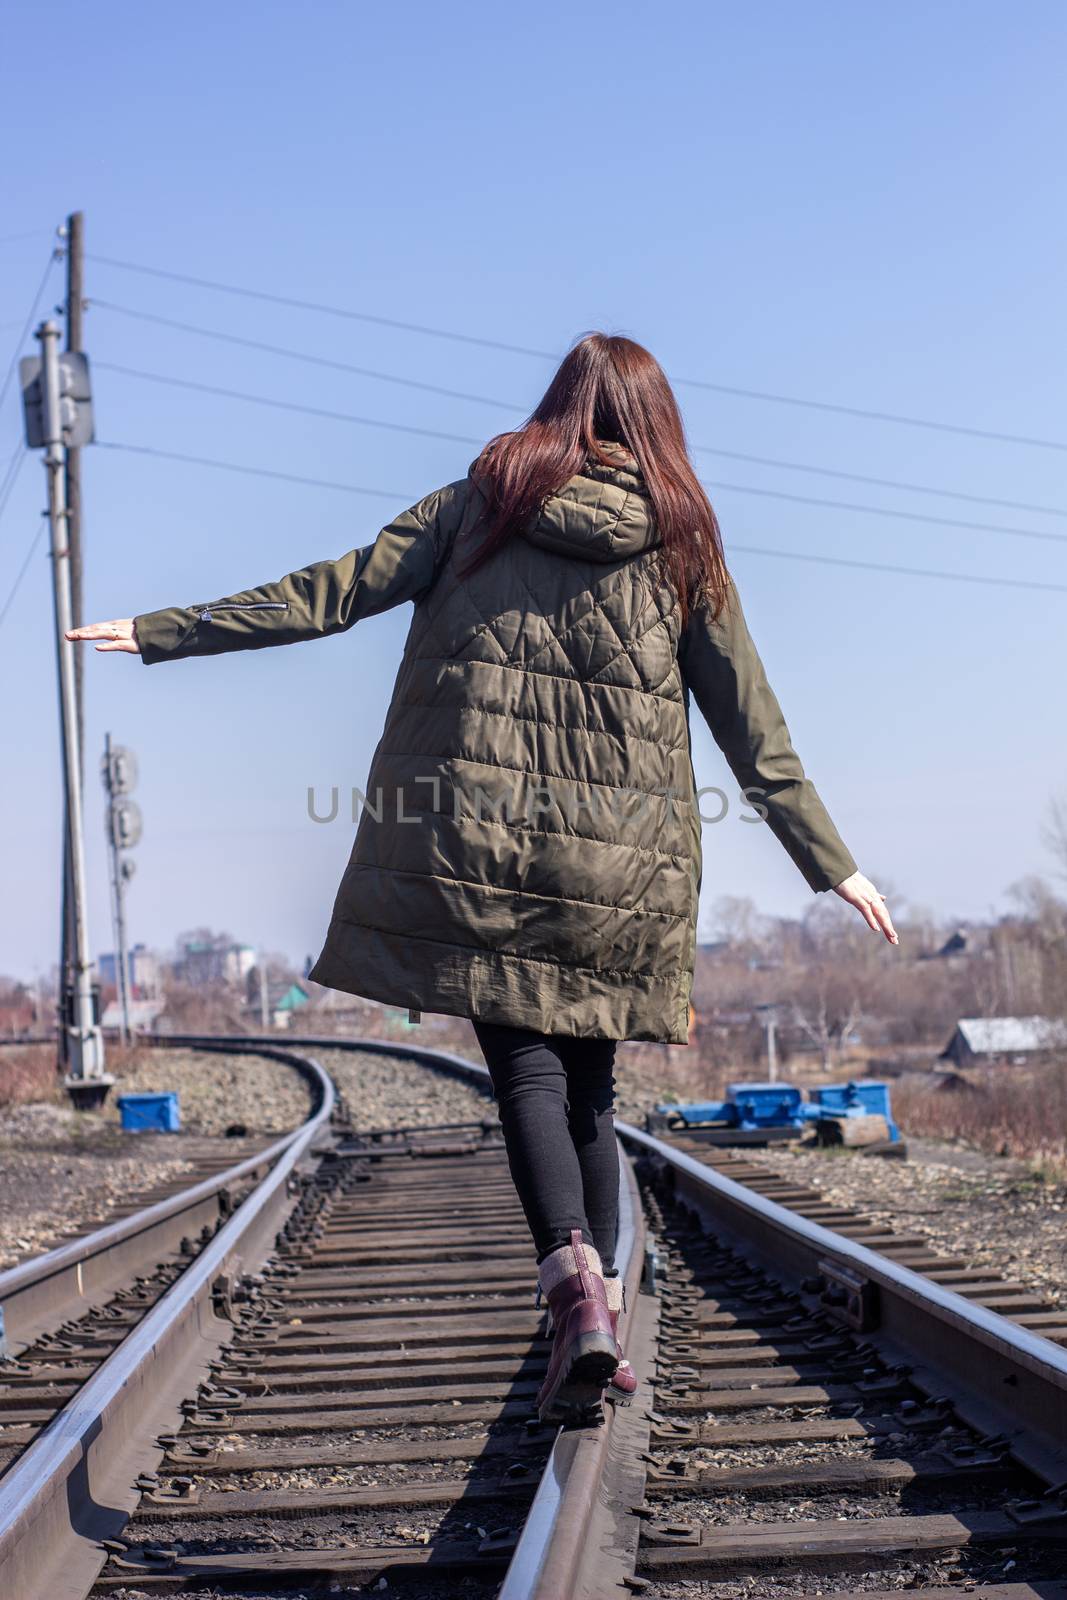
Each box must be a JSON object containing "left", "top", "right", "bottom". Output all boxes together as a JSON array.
[{"left": 136, "top": 445, "right": 856, "bottom": 1043}]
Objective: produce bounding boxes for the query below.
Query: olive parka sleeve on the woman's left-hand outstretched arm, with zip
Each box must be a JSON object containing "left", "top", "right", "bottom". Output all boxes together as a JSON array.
[{"left": 134, "top": 480, "right": 466, "bottom": 666}]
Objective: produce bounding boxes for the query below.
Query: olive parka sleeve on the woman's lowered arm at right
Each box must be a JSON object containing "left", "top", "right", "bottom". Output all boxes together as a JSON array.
[{"left": 678, "top": 584, "right": 856, "bottom": 891}]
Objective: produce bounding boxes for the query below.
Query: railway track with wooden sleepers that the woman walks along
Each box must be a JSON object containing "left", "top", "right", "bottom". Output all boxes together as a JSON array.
[{"left": 0, "top": 1040, "right": 1067, "bottom": 1600}]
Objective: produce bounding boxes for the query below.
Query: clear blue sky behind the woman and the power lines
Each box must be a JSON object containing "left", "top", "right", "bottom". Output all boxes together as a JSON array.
[{"left": 0, "top": 0, "right": 1067, "bottom": 978}]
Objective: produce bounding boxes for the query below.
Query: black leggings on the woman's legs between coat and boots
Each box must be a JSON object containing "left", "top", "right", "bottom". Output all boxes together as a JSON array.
[{"left": 474, "top": 1022, "right": 619, "bottom": 1270}]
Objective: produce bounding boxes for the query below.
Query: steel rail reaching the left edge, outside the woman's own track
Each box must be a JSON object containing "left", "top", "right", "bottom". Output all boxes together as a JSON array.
[{"left": 0, "top": 1035, "right": 329, "bottom": 1357}]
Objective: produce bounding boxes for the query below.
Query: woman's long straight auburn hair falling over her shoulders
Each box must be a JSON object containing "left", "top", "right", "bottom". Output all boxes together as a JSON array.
[{"left": 462, "top": 333, "right": 729, "bottom": 624}]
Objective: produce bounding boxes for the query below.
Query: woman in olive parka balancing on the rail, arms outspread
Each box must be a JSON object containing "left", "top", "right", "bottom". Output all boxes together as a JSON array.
[{"left": 67, "top": 333, "right": 896, "bottom": 1418}]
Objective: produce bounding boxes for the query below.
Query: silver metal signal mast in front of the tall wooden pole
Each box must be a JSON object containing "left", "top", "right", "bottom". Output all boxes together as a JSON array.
[{"left": 21, "top": 322, "right": 114, "bottom": 1106}]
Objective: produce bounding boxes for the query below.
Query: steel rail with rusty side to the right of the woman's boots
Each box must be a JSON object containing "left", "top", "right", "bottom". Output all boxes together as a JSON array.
[{"left": 616, "top": 1123, "right": 1067, "bottom": 1483}]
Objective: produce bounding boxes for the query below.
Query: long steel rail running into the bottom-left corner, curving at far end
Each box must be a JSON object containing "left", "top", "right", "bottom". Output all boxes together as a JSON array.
[{"left": 0, "top": 1040, "right": 334, "bottom": 1600}]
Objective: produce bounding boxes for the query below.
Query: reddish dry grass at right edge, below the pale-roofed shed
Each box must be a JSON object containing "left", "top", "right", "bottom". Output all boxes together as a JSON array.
[{"left": 893, "top": 1062, "right": 1067, "bottom": 1178}]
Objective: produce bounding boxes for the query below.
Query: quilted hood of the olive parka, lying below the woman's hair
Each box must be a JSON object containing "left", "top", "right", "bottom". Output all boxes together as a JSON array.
[{"left": 467, "top": 440, "right": 659, "bottom": 562}]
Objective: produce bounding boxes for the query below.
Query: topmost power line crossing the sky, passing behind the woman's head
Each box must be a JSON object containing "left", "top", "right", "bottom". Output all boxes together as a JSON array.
[{"left": 90, "top": 254, "right": 1067, "bottom": 451}]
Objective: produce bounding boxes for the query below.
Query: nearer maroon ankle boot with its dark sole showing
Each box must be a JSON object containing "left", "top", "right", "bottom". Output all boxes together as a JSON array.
[{"left": 537, "top": 1229, "right": 619, "bottom": 1422}]
